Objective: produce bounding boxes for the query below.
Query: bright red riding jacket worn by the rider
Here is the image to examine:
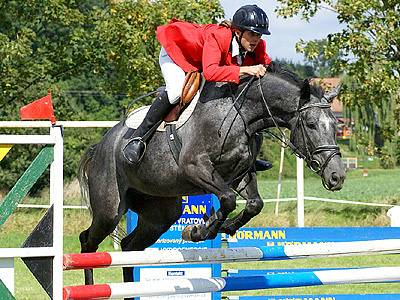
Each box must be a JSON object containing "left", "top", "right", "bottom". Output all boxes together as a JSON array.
[{"left": 157, "top": 20, "right": 271, "bottom": 83}]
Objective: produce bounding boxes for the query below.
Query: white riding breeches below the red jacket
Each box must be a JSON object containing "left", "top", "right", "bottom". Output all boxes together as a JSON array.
[{"left": 158, "top": 47, "right": 185, "bottom": 104}]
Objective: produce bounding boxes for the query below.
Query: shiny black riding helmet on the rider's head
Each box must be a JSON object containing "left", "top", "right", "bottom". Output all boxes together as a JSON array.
[{"left": 232, "top": 5, "right": 271, "bottom": 35}]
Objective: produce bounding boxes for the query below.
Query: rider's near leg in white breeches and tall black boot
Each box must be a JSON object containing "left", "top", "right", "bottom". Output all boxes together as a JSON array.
[{"left": 123, "top": 48, "right": 185, "bottom": 164}]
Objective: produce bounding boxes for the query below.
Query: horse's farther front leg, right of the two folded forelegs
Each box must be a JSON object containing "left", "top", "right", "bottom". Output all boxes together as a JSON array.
[{"left": 219, "top": 172, "right": 264, "bottom": 235}]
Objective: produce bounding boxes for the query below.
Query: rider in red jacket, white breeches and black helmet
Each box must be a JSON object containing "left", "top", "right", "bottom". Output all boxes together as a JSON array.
[{"left": 123, "top": 5, "right": 271, "bottom": 170}]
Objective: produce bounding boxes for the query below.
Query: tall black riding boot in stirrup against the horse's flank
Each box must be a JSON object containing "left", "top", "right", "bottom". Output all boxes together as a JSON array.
[{"left": 122, "top": 91, "right": 172, "bottom": 164}]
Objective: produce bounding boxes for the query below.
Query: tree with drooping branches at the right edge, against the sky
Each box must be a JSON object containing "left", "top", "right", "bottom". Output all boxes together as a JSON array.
[{"left": 277, "top": 0, "right": 400, "bottom": 163}]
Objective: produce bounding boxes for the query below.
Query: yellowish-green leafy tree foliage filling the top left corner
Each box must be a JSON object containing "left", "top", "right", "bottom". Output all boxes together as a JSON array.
[{"left": 0, "top": 0, "right": 99, "bottom": 119}]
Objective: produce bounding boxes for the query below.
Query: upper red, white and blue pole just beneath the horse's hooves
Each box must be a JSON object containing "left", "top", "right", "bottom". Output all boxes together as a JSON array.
[{"left": 64, "top": 239, "right": 400, "bottom": 270}]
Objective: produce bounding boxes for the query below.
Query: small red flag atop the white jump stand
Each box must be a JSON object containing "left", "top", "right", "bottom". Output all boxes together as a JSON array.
[{"left": 19, "top": 92, "right": 56, "bottom": 125}]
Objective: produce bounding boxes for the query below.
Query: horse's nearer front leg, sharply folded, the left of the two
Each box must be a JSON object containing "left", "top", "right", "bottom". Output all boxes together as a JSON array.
[{"left": 181, "top": 154, "right": 236, "bottom": 242}]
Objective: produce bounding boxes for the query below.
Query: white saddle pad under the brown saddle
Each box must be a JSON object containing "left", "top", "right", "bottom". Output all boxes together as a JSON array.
[{"left": 125, "top": 77, "right": 205, "bottom": 131}]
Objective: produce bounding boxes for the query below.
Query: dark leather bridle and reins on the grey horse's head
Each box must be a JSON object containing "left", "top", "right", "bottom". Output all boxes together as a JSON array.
[{"left": 258, "top": 78, "right": 341, "bottom": 180}]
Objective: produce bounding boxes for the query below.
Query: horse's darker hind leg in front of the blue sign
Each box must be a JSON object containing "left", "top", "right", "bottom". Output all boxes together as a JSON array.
[{"left": 121, "top": 196, "right": 182, "bottom": 282}]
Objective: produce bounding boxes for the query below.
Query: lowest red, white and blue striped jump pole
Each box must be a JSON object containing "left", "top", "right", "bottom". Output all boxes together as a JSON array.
[{"left": 64, "top": 267, "right": 400, "bottom": 300}]
